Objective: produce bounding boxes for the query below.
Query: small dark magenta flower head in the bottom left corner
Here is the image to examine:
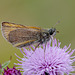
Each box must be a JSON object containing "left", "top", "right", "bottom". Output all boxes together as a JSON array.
[{"left": 3, "top": 67, "right": 21, "bottom": 75}]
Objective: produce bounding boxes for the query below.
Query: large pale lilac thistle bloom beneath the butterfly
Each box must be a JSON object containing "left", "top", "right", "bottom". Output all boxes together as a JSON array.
[{"left": 15, "top": 39, "right": 75, "bottom": 75}]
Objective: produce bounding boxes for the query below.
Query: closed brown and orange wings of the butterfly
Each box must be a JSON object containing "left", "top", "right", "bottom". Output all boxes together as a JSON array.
[{"left": 2, "top": 22, "right": 41, "bottom": 47}]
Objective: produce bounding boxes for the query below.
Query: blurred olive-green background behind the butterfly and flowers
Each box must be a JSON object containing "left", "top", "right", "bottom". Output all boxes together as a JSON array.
[{"left": 0, "top": 0, "right": 75, "bottom": 67}]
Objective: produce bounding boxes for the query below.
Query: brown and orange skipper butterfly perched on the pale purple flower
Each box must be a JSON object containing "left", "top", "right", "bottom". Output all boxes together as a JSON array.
[{"left": 1, "top": 22, "right": 56, "bottom": 48}]
